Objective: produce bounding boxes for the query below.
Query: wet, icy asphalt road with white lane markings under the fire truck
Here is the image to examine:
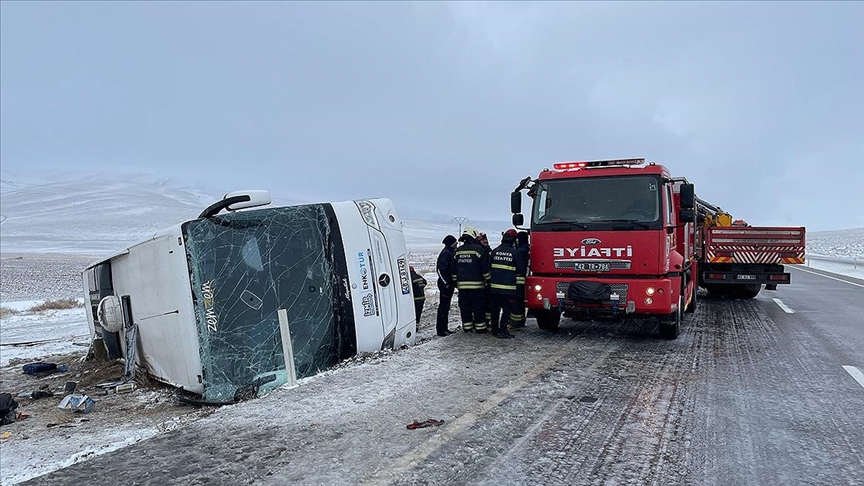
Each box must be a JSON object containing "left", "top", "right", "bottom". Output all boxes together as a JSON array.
[{"left": 23, "top": 269, "right": 864, "bottom": 486}]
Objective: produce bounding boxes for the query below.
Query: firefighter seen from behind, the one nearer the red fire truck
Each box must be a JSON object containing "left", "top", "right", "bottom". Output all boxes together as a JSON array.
[{"left": 489, "top": 229, "right": 525, "bottom": 339}]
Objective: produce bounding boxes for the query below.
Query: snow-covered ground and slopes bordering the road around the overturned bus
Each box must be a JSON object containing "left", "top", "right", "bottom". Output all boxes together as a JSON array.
[{"left": 0, "top": 176, "right": 864, "bottom": 484}]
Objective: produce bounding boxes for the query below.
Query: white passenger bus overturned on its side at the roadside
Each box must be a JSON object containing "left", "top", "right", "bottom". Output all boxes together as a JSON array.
[{"left": 83, "top": 191, "right": 416, "bottom": 403}]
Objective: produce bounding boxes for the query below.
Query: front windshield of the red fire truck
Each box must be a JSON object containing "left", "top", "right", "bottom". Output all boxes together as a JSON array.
[{"left": 531, "top": 175, "right": 662, "bottom": 230}]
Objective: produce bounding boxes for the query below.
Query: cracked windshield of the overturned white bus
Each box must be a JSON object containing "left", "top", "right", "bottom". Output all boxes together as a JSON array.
[{"left": 182, "top": 204, "right": 356, "bottom": 402}]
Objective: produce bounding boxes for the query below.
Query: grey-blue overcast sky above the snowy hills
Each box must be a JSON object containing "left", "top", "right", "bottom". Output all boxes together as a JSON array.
[{"left": 0, "top": 1, "right": 864, "bottom": 230}]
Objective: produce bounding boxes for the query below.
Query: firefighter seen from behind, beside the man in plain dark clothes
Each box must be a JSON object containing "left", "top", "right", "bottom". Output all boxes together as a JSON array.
[{"left": 453, "top": 226, "right": 489, "bottom": 334}]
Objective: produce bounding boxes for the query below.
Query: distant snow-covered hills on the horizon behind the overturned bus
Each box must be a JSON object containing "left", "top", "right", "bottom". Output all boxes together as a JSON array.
[{"left": 0, "top": 173, "right": 507, "bottom": 256}]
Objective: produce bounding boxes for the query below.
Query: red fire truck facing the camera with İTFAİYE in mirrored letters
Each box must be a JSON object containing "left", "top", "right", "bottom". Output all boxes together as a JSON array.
[{"left": 511, "top": 158, "right": 698, "bottom": 339}]
